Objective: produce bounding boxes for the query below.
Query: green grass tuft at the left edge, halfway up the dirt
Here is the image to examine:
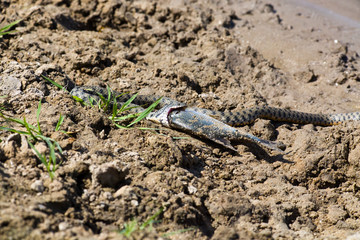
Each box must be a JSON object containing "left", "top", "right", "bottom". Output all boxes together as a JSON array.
[{"left": 0, "top": 100, "right": 64, "bottom": 179}]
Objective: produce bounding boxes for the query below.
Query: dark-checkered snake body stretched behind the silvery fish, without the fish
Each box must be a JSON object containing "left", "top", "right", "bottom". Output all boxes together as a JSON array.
[{"left": 70, "top": 86, "right": 360, "bottom": 126}]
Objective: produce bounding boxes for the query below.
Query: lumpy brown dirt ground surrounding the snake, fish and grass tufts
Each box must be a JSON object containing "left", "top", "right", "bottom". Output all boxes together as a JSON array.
[{"left": 0, "top": 0, "right": 360, "bottom": 239}]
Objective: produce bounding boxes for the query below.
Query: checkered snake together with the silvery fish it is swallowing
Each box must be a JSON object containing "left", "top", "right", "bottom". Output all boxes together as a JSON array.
[{"left": 70, "top": 86, "right": 360, "bottom": 153}]
